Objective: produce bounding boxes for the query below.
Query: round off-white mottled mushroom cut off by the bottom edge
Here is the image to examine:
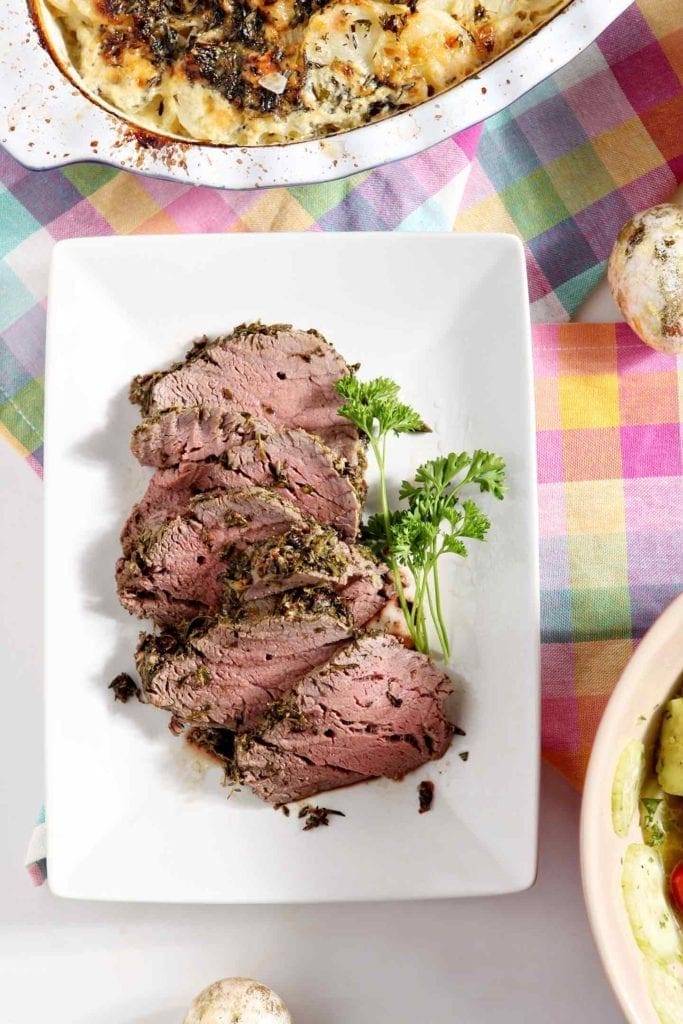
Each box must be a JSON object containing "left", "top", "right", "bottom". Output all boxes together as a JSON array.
[{"left": 183, "top": 978, "right": 293, "bottom": 1024}]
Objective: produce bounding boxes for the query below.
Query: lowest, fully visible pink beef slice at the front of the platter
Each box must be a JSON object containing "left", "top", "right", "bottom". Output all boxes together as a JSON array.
[{"left": 234, "top": 635, "right": 453, "bottom": 805}]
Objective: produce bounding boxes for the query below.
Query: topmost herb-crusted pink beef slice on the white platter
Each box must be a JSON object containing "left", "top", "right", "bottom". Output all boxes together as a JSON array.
[{"left": 130, "top": 324, "right": 360, "bottom": 466}]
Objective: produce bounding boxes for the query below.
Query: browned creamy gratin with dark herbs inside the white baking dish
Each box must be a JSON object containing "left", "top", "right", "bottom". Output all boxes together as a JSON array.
[{"left": 46, "top": 0, "right": 568, "bottom": 145}]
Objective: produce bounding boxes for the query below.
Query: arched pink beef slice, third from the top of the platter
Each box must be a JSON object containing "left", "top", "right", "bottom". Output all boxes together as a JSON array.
[{"left": 121, "top": 430, "right": 360, "bottom": 555}]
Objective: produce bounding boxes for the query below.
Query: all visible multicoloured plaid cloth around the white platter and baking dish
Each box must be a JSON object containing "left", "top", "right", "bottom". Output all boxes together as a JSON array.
[{"left": 0, "top": 0, "right": 683, "bottom": 881}]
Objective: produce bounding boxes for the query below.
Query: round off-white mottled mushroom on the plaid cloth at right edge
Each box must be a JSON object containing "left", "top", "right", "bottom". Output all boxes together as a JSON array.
[{"left": 607, "top": 203, "right": 683, "bottom": 354}]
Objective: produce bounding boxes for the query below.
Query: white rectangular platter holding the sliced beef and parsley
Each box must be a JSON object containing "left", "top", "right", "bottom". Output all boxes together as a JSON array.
[{"left": 45, "top": 233, "right": 540, "bottom": 903}]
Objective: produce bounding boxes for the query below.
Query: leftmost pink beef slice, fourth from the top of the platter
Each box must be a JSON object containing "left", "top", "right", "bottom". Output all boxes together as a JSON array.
[{"left": 116, "top": 487, "right": 307, "bottom": 626}]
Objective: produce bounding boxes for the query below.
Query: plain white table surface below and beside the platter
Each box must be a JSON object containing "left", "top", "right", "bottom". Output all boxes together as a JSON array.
[{"left": 0, "top": 287, "right": 623, "bottom": 1024}]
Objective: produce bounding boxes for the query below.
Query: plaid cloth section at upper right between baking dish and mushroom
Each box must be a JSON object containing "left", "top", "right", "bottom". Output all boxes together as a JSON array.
[{"left": 455, "top": 0, "right": 683, "bottom": 323}]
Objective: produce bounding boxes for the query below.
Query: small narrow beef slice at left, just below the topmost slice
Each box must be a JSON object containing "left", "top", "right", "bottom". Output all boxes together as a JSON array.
[{"left": 130, "top": 407, "right": 273, "bottom": 469}]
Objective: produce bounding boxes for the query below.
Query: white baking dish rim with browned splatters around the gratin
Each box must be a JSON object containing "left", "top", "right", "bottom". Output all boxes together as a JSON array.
[{"left": 0, "top": 0, "right": 629, "bottom": 188}]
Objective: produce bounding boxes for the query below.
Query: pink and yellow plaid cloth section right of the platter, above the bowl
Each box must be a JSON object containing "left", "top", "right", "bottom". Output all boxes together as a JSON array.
[{"left": 533, "top": 324, "right": 683, "bottom": 786}]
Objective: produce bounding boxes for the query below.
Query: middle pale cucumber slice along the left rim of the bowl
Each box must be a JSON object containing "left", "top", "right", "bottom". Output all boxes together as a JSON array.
[{"left": 622, "top": 843, "right": 681, "bottom": 964}]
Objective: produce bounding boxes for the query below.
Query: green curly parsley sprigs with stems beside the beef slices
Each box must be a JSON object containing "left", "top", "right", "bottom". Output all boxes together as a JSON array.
[{"left": 337, "top": 377, "right": 505, "bottom": 659}]
